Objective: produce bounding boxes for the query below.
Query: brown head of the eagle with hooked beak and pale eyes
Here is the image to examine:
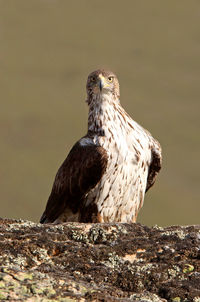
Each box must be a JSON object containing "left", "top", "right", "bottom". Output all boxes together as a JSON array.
[{"left": 86, "top": 69, "right": 119, "bottom": 103}]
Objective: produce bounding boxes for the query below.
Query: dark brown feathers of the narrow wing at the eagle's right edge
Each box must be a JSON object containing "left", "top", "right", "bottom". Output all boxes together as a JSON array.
[{"left": 146, "top": 148, "right": 162, "bottom": 192}]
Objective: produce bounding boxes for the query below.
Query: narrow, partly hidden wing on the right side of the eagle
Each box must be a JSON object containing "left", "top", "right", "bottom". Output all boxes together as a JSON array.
[{"left": 146, "top": 139, "right": 162, "bottom": 192}]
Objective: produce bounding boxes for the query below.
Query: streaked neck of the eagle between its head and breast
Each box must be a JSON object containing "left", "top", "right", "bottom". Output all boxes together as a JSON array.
[{"left": 88, "top": 95, "right": 122, "bottom": 136}]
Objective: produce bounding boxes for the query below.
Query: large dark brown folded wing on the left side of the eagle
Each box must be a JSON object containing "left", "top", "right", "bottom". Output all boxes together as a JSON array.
[{"left": 40, "top": 137, "right": 108, "bottom": 223}]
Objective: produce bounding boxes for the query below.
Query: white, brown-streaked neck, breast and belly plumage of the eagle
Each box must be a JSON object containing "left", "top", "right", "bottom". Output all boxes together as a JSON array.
[{"left": 82, "top": 96, "right": 160, "bottom": 222}]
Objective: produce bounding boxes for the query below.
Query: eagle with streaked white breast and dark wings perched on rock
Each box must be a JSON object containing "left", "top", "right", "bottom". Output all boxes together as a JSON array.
[{"left": 40, "top": 69, "right": 162, "bottom": 224}]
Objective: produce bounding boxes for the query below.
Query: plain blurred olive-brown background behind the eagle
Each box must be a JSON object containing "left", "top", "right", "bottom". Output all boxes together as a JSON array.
[{"left": 0, "top": 0, "right": 200, "bottom": 226}]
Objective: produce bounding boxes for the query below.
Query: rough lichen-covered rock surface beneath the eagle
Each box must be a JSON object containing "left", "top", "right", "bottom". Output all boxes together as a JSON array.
[{"left": 0, "top": 219, "right": 200, "bottom": 302}]
